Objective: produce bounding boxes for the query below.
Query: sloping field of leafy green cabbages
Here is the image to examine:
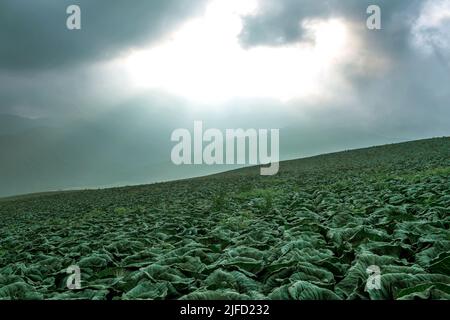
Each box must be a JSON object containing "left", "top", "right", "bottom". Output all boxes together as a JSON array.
[{"left": 0, "top": 138, "right": 450, "bottom": 300}]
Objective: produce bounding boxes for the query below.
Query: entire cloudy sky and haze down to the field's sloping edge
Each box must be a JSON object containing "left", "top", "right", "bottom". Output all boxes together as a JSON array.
[{"left": 0, "top": 0, "right": 450, "bottom": 195}]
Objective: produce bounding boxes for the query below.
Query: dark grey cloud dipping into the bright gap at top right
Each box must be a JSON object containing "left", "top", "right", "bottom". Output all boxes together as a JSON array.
[{"left": 240, "top": 0, "right": 423, "bottom": 57}]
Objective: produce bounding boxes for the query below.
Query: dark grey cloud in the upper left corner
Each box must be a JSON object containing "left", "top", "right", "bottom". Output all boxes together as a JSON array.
[{"left": 0, "top": 0, "right": 204, "bottom": 70}]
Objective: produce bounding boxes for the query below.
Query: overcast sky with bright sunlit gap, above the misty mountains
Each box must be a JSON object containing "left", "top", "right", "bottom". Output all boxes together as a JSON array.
[{"left": 0, "top": 0, "right": 450, "bottom": 124}]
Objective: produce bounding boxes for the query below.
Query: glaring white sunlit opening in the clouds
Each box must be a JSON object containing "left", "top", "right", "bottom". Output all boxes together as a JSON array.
[{"left": 125, "top": 0, "right": 350, "bottom": 102}]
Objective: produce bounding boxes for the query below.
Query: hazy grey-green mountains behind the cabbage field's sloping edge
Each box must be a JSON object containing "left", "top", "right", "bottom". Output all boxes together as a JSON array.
[{"left": 0, "top": 107, "right": 446, "bottom": 196}]
